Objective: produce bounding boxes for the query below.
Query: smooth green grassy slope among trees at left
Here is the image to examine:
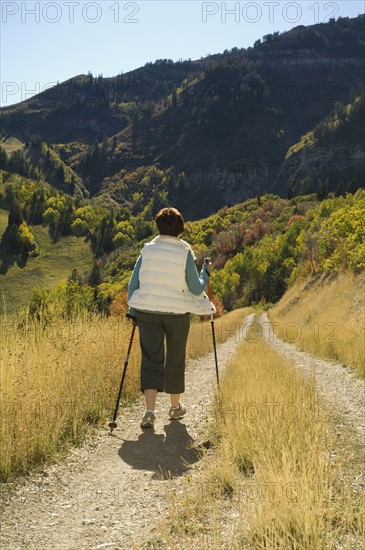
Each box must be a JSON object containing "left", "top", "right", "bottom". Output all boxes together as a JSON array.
[{"left": 0, "top": 209, "right": 93, "bottom": 314}]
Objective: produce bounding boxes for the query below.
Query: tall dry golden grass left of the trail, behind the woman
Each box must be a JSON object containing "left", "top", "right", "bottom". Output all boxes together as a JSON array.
[{"left": 0, "top": 313, "right": 247, "bottom": 480}]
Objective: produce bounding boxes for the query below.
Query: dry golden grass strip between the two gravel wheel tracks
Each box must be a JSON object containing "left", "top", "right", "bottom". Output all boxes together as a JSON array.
[{"left": 161, "top": 328, "right": 364, "bottom": 550}]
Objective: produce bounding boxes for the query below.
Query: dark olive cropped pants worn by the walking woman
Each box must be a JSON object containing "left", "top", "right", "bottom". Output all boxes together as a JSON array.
[{"left": 136, "top": 311, "right": 190, "bottom": 393}]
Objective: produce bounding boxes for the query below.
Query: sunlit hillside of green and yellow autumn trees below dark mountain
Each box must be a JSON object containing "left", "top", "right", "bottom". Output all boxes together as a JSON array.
[{"left": 0, "top": 164, "right": 365, "bottom": 314}]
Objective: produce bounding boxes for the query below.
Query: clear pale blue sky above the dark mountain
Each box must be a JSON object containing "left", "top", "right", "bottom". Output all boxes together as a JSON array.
[{"left": 0, "top": 0, "right": 365, "bottom": 105}]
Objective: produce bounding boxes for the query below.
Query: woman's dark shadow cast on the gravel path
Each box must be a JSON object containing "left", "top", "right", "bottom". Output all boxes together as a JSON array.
[{"left": 118, "top": 420, "right": 202, "bottom": 480}]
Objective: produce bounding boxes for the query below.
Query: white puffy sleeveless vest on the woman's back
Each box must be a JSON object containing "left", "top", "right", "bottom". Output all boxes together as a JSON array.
[{"left": 128, "top": 235, "right": 216, "bottom": 315}]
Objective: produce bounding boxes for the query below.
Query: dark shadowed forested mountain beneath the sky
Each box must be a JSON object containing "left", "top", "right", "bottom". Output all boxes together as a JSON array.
[{"left": 0, "top": 15, "right": 365, "bottom": 219}]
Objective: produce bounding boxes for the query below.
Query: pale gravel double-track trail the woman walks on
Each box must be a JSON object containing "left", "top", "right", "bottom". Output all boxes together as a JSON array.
[{"left": 0, "top": 315, "right": 365, "bottom": 550}]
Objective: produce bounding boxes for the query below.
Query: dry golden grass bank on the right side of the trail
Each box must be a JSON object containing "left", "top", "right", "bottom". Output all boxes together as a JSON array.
[{"left": 269, "top": 273, "right": 365, "bottom": 377}]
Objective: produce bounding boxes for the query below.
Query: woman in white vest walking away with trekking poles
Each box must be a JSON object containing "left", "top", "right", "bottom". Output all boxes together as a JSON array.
[{"left": 128, "top": 208, "right": 215, "bottom": 428}]
